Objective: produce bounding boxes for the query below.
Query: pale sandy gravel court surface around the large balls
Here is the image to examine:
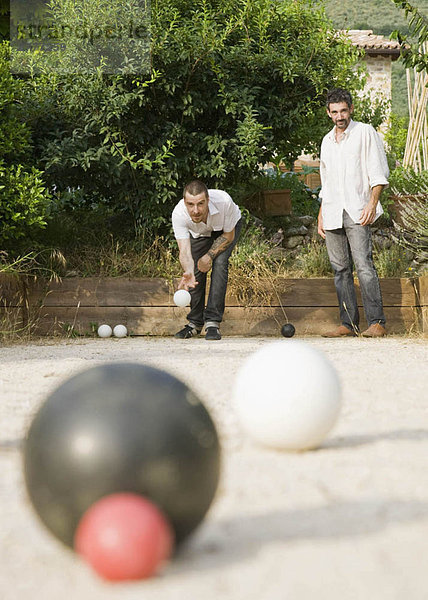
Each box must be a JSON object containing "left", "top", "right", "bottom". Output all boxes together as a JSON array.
[{"left": 0, "top": 337, "right": 428, "bottom": 600}]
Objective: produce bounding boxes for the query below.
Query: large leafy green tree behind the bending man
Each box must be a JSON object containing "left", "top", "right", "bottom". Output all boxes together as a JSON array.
[{"left": 27, "top": 0, "right": 368, "bottom": 237}]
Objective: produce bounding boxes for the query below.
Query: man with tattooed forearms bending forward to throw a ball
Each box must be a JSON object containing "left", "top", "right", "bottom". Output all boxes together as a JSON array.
[{"left": 172, "top": 180, "right": 242, "bottom": 340}]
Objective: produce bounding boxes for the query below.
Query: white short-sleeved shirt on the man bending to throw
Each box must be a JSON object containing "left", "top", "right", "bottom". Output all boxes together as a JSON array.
[{"left": 172, "top": 190, "right": 241, "bottom": 240}]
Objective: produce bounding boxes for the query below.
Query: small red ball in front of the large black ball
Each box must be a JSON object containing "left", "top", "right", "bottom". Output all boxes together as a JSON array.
[{"left": 74, "top": 492, "right": 174, "bottom": 581}]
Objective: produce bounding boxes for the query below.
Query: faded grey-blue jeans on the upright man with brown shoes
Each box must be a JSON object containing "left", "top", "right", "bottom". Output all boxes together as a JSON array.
[{"left": 325, "top": 211, "right": 385, "bottom": 329}]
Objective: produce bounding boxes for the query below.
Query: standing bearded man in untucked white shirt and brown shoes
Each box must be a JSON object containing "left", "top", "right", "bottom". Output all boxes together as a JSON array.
[{"left": 318, "top": 89, "right": 389, "bottom": 337}]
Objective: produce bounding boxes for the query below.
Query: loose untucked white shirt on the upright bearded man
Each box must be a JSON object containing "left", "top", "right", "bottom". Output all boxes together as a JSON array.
[{"left": 320, "top": 120, "right": 389, "bottom": 229}]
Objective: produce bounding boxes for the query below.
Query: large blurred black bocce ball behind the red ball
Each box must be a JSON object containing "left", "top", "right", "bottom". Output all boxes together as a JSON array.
[{"left": 24, "top": 363, "right": 220, "bottom": 547}]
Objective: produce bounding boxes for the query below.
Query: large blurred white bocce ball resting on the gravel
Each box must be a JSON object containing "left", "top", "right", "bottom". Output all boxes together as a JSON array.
[{"left": 233, "top": 340, "right": 341, "bottom": 450}]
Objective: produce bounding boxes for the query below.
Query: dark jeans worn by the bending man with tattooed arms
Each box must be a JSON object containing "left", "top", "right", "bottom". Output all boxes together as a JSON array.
[{"left": 187, "top": 219, "right": 242, "bottom": 329}]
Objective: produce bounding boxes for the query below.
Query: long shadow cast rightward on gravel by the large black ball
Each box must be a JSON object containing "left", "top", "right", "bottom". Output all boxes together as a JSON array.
[{"left": 170, "top": 500, "right": 428, "bottom": 570}]
